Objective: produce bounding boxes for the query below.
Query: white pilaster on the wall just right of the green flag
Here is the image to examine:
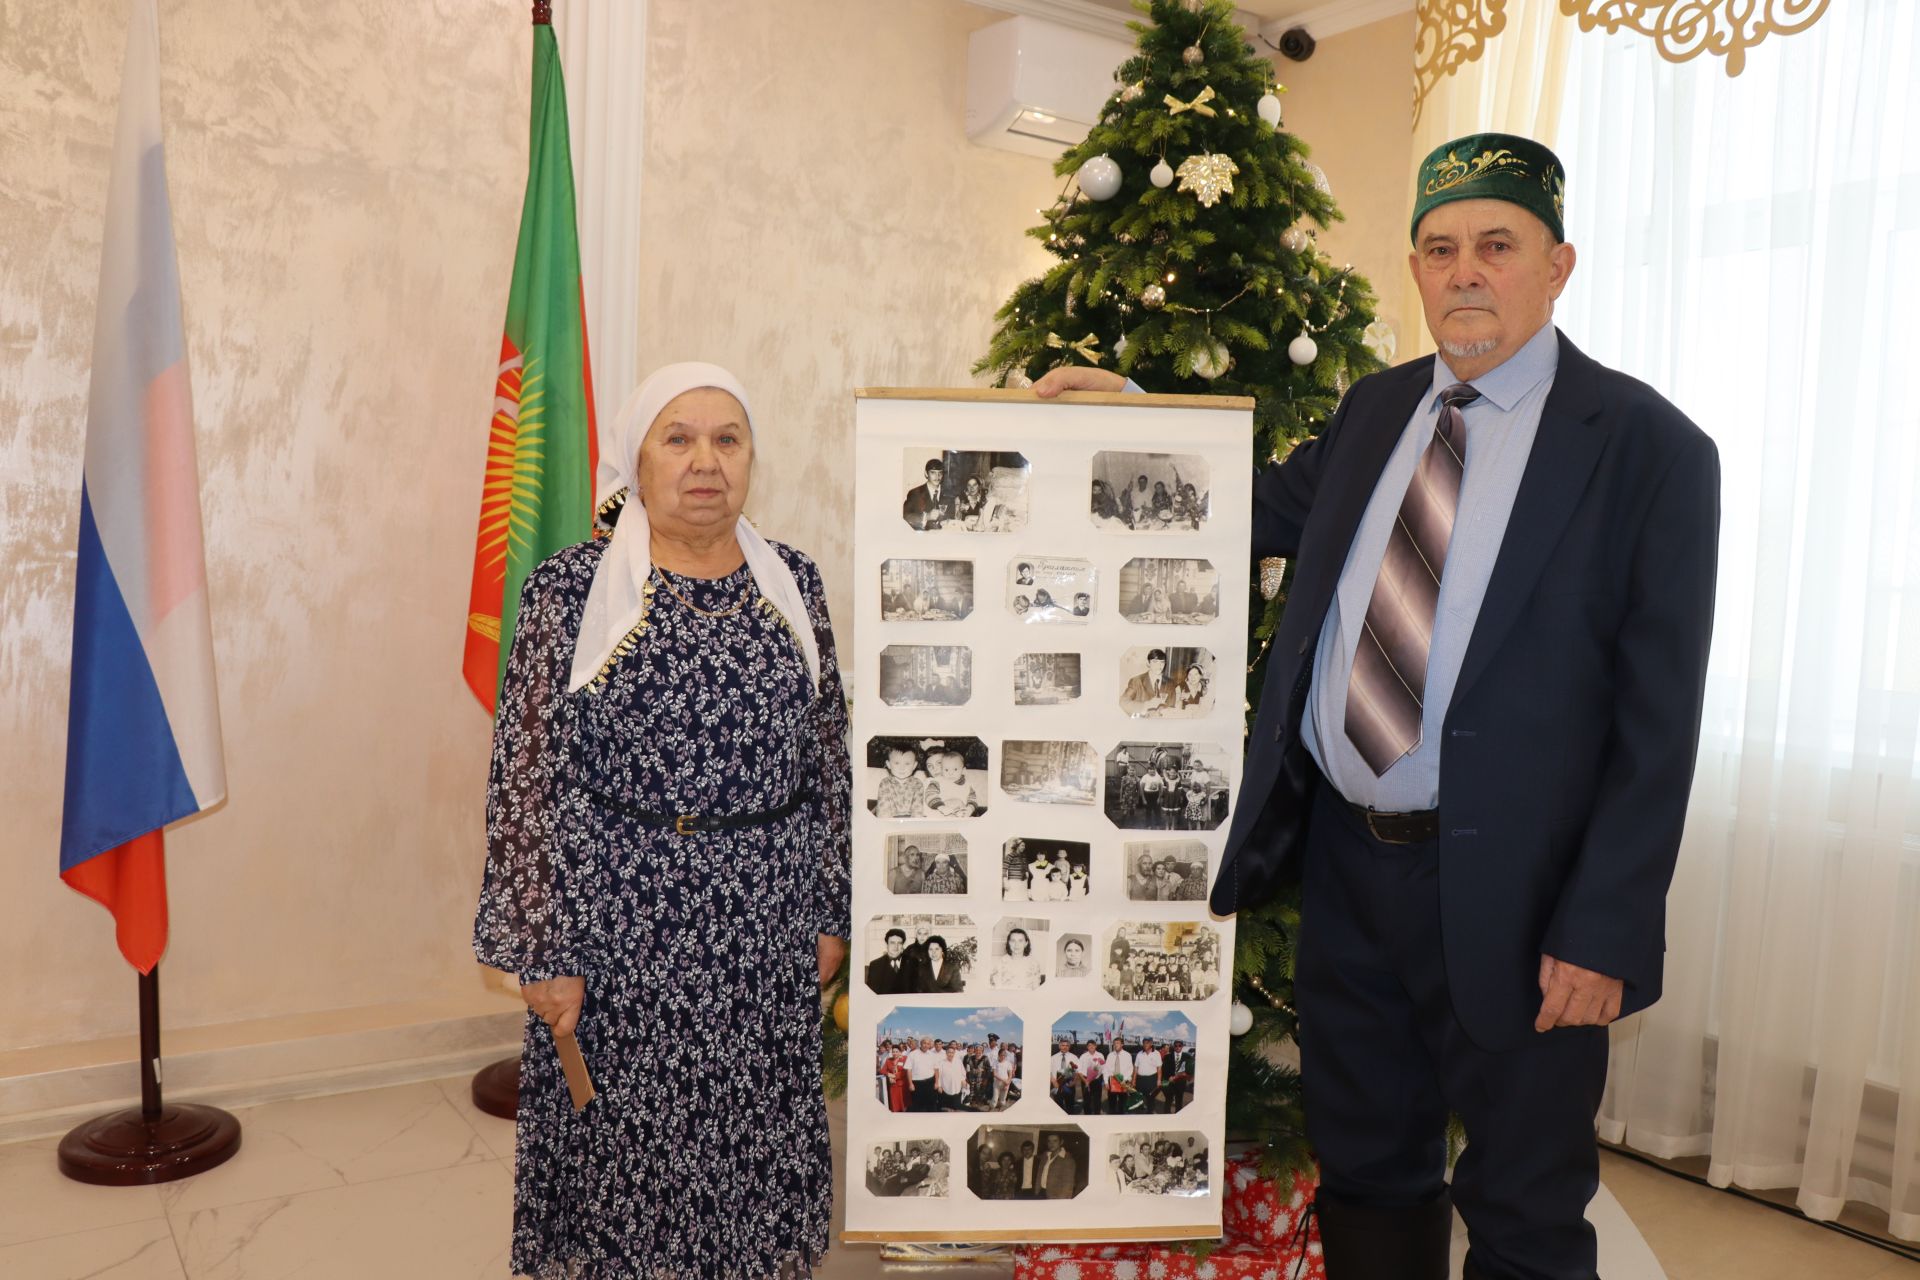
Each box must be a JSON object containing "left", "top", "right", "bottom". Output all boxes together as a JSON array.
[{"left": 553, "top": 0, "right": 647, "bottom": 415}]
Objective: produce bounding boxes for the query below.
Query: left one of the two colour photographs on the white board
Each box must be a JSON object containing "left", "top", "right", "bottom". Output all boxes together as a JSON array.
[{"left": 874, "top": 1007, "right": 1023, "bottom": 1111}]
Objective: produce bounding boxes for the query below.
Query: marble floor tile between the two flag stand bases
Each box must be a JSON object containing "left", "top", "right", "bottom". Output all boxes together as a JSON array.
[{"left": 159, "top": 1082, "right": 493, "bottom": 1226}]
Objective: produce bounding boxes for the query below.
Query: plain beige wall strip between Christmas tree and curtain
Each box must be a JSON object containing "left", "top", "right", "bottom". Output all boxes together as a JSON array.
[{"left": 1273, "top": 10, "right": 1421, "bottom": 359}]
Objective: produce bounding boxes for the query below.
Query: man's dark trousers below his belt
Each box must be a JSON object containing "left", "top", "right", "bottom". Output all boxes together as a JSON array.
[{"left": 1294, "top": 779, "right": 1607, "bottom": 1280}]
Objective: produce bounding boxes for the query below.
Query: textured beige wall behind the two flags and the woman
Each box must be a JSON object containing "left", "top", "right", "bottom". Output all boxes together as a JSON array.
[{"left": 0, "top": 0, "right": 1056, "bottom": 1050}]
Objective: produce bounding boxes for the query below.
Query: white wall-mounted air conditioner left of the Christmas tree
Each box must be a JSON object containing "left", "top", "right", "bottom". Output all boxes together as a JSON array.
[{"left": 966, "top": 15, "right": 1135, "bottom": 159}]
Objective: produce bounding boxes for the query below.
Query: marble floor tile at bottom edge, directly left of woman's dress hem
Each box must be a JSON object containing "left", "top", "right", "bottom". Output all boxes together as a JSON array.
[{"left": 179, "top": 1159, "right": 513, "bottom": 1280}]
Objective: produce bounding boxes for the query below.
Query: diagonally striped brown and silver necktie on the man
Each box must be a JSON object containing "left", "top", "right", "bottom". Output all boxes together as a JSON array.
[{"left": 1346, "top": 382, "right": 1480, "bottom": 775}]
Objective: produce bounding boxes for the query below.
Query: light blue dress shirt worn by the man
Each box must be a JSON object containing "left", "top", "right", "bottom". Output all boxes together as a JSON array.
[{"left": 1300, "top": 324, "right": 1559, "bottom": 812}]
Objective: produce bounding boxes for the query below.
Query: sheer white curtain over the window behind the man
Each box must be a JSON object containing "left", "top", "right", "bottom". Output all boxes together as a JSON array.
[{"left": 1530, "top": 0, "right": 1920, "bottom": 1240}]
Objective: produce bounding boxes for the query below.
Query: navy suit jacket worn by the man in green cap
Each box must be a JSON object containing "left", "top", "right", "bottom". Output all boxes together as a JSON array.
[{"left": 1212, "top": 334, "right": 1720, "bottom": 1050}]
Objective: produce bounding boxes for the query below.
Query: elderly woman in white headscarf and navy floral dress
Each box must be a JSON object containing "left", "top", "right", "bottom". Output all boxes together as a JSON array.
[{"left": 474, "top": 365, "right": 851, "bottom": 1280}]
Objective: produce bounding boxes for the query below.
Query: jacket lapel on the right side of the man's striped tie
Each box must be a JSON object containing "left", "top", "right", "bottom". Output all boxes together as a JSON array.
[{"left": 1453, "top": 334, "right": 1607, "bottom": 706}]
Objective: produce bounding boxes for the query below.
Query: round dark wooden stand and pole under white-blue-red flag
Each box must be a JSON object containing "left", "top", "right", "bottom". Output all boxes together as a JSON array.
[{"left": 60, "top": 965, "right": 240, "bottom": 1186}]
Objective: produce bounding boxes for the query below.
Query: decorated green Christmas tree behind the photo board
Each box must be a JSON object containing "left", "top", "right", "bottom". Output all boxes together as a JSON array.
[{"left": 973, "top": 0, "right": 1382, "bottom": 1171}]
